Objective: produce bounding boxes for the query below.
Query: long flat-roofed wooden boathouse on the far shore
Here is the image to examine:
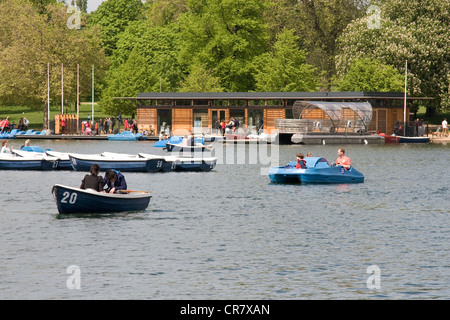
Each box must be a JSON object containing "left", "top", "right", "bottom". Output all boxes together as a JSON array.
[{"left": 116, "top": 91, "right": 431, "bottom": 134}]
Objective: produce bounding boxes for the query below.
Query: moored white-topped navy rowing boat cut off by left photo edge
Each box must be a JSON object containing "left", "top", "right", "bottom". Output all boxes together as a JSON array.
[{"left": 0, "top": 153, "right": 54, "bottom": 171}]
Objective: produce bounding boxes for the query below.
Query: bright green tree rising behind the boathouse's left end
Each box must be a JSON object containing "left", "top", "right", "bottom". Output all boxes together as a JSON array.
[{"left": 100, "top": 21, "right": 182, "bottom": 114}]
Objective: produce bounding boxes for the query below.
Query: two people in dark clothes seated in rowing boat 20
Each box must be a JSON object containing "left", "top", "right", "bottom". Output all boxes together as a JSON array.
[{"left": 80, "top": 163, "right": 127, "bottom": 193}]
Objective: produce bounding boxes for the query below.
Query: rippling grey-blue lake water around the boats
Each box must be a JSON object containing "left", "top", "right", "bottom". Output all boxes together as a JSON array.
[{"left": 0, "top": 140, "right": 450, "bottom": 300}]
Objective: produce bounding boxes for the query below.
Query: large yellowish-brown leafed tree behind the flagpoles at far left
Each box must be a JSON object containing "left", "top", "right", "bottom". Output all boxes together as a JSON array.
[{"left": 0, "top": 0, "right": 106, "bottom": 124}]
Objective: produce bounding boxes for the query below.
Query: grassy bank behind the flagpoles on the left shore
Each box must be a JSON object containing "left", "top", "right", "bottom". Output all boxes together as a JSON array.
[{"left": 0, "top": 102, "right": 131, "bottom": 130}]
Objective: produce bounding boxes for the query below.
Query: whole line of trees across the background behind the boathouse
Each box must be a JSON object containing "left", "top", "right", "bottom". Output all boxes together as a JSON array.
[{"left": 0, "top": 0, "right": 450, "bottom": 120}]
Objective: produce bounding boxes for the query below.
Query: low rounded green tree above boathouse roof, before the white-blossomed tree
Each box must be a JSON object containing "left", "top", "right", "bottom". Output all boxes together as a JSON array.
[{"left": 336, "top": 58, "right": 404, "bottom": 92}]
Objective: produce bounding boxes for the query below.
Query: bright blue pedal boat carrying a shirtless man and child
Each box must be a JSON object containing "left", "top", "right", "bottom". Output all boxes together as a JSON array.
[{"left": 269, "top": 157, "right": 364, "bottom": 184}]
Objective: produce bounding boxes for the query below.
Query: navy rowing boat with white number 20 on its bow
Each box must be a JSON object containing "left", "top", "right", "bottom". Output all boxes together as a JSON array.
[{"left": 52, "top": 184, "right": 151, "bottom": 214}]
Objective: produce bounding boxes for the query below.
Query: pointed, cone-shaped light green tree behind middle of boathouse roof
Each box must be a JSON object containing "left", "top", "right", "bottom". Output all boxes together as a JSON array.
[{"left": 255, "top": 30, "right": 318, "bottom": 92}]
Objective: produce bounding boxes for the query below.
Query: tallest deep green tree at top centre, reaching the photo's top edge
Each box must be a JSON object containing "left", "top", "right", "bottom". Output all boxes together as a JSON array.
[{"left": 178, "top": 0, "right": 268, "bottom": 91}]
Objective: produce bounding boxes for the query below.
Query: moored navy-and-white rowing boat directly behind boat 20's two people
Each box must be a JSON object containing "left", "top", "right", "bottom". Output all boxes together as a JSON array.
[{"left": 69, "top": 153, "right": 163, "bottom": 172}]
